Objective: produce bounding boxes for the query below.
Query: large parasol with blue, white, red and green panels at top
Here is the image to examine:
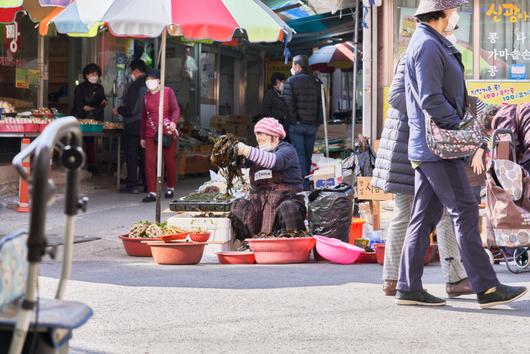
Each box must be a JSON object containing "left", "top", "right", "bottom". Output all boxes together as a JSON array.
[{"left": 47, "top": 0, "right": 292, "bottom": 42}]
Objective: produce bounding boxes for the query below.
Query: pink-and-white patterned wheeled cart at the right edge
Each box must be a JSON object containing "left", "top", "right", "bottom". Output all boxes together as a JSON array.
[{"left": 486, "top": 129, "right": 530, "bottom": 273}]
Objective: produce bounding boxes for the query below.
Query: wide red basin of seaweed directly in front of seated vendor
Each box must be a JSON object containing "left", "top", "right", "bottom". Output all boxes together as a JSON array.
[{"left": 246, "top": 237, "right": 316, "bottom": 264}]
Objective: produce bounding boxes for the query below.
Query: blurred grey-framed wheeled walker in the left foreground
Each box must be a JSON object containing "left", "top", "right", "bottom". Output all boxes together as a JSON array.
[{"left": 0, "top": 117, "right": 92, "bottom": 354}]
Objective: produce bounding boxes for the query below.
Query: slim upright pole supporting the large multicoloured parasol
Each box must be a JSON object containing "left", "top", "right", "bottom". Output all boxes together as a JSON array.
[{"left": 156, "top": 28, "right": 167, "bottom": 223}]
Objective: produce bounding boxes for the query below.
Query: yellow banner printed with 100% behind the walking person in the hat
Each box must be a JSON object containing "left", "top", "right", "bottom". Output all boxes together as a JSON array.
[{"left": 467, "top": 80, "right": 530, "bottom": 105}]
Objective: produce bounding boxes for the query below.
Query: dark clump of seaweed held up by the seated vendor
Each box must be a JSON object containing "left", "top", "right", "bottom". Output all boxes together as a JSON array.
[{"left": 210, "top": 134, "right": 245, "bottom": 195}]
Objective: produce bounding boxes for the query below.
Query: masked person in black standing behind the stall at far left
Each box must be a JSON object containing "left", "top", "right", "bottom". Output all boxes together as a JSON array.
[{"left": 72, "top": 63, "right": 107, "bottom": 175}]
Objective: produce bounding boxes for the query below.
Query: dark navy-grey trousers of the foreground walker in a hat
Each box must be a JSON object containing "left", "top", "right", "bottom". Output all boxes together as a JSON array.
[{"left": 397, "top": 160, "right": 499, "bottom": 292}]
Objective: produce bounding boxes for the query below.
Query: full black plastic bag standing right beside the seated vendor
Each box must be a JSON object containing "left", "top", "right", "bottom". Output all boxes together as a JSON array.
[{"left": 308, "top": 184, "right": 354, "bottom": 242}]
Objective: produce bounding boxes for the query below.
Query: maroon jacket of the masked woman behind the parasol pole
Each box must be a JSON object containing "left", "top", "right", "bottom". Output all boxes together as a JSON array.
[{"left": 140, "top": 87, "right": 180, "bottom": 139}]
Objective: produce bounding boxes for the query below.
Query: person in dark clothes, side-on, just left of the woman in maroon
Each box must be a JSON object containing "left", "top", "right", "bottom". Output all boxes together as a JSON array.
[{"left": 112, "top": 59, "right": 147, "bottom": 194}]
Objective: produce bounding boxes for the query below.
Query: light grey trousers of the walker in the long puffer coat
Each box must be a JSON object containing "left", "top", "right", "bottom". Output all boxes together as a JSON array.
[{"left": 383, "top": 193, "right": 467, "bottom": 283}]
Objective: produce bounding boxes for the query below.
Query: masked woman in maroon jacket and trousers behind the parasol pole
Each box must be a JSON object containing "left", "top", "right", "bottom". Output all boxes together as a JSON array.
[{"left": 140, "top": 70, "right": 180, "bottom": 203}]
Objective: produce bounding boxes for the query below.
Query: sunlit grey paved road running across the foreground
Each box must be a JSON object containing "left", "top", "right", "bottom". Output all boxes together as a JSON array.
[{"left": 0, "top": 180, "right": 530, "bottom": 353}]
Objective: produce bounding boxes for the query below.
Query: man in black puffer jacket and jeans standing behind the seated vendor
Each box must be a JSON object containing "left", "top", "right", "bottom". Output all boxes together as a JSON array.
[{"left": 283, "top": 55, "right": 323, "bottom": 190}]
